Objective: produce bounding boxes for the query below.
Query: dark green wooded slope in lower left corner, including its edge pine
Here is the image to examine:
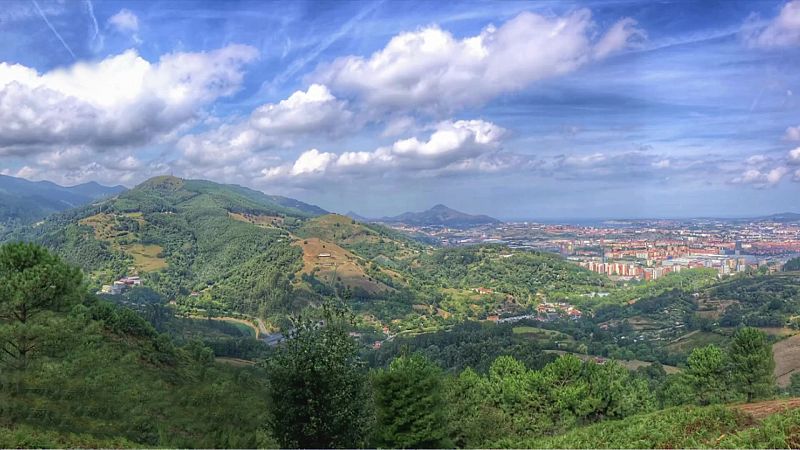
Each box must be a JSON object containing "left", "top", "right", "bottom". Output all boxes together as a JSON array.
[{"left": 0, "top": 244, "right": 272, "bottom": 447}]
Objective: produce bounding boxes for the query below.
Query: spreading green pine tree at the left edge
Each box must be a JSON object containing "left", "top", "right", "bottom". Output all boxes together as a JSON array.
[{"left": 0, "top": 243, "right": 84, "bottom": 370}]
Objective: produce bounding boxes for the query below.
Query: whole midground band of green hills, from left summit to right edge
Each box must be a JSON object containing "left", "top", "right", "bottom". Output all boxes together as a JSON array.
[{"left": 6, "top": 177, "right": 800, "bottom": 358}]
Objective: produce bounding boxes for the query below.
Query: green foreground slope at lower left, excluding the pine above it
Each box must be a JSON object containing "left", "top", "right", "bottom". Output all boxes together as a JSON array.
[{"left": 0, "top": 301, "right": 268, "bottom": 448}]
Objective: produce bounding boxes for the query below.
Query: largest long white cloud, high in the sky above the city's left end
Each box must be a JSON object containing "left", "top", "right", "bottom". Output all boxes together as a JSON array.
[{"left": 312, "top": 9, "right": 644, "bottom": 111}]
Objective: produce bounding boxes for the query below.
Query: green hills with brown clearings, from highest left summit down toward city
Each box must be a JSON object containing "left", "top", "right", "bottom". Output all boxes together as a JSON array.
[{"left": 2, "top": 177, "right": 604, "bottom": 334}]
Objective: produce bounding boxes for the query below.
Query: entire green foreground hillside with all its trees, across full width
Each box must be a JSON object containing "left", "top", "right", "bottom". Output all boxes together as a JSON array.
[{"left": 0, "top": 244, "right": 800, "bottom": 448}]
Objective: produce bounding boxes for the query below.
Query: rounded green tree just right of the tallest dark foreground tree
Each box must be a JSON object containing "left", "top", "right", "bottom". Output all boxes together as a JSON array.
[{"left": 372, "top": 354, "right": 452, "bottom": 448}]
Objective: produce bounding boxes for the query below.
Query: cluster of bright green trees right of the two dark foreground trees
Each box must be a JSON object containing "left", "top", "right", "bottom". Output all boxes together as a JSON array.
[{"left": 447, "top": 356, "right": 655, "bottom": 447}]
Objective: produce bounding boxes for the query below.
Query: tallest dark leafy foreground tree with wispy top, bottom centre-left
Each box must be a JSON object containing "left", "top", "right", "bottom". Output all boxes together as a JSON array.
[{"left": 266, "top": 305, "right": 369, "bottom": 448}]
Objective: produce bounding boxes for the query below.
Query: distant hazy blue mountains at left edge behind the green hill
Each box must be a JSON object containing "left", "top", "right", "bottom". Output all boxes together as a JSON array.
[{"left": 0, "top": 175, "right": 125, "bottom": 232}]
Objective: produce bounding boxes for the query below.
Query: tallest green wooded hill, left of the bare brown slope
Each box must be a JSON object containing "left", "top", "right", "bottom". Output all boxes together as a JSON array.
[{"left": 6, "top": 177, "right": 326, "bottom": 313}]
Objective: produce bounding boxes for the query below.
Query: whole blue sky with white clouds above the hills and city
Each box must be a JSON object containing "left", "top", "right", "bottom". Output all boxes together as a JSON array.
[{"left": 0, "top": 0, "right": 800, "bottom": 219}]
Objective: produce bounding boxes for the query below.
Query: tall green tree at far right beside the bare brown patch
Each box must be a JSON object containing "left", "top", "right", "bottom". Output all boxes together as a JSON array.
[{"left": 728, "top": 327, "right": 775, "bottom": 402}]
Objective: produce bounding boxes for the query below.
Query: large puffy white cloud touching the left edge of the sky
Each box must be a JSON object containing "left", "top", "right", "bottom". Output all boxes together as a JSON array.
[{"left": 0, "top": 45, "right": 257, "bottom": 155}]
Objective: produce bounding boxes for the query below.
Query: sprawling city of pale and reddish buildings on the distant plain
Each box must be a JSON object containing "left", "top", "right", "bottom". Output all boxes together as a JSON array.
[{"left": 388, "top": 219, "right": 800, "bottom": 280}]
